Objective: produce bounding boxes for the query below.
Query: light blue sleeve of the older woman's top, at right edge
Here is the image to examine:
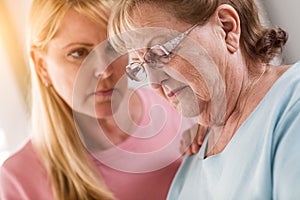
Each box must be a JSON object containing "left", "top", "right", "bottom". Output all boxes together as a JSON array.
[{"left": 269, "top": 62, "right": 300, "bottom": 199}]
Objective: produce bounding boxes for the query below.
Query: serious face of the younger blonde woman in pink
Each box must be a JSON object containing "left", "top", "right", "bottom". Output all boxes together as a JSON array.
[{"left": 38, "top": 10, "right": 127, "bottom": 118}]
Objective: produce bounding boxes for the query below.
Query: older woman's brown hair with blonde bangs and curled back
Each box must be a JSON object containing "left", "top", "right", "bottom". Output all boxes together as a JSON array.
[{"left": 109, "top": 0, "right": 288, "bottom": 63}]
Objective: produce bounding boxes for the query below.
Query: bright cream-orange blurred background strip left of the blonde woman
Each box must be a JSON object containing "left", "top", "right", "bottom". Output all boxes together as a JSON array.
[{"left": 0, "top": 0, "right": 30, "bottom": 165}]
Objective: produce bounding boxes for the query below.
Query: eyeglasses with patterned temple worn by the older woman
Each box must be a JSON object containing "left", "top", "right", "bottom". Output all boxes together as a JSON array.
[{"left": 125, "top": 24, "right": 198, "bottom": 82}]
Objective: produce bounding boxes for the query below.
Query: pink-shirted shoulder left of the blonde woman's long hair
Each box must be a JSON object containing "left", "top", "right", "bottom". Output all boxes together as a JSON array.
[{"left": 0, "top": 141, "right": 51, "bottom": 199}]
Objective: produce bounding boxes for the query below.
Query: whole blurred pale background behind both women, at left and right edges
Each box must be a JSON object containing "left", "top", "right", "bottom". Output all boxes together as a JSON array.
[{"left": 0, "top": 0, "right": 300, "bottom": 165}]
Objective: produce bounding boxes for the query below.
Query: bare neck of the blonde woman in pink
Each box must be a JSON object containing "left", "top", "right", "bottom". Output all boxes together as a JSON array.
[{"left": 76, "top": 90, "right": 142, "bottom": 151}]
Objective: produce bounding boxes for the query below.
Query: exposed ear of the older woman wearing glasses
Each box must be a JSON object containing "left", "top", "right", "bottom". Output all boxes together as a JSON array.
[{"left": 215, "top": 4, "right": 241, "bottom": 53}]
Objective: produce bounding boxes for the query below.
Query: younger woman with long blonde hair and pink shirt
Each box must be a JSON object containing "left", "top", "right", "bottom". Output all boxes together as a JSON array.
[{"left": 0, "top": 0, "right": 195, "bottom": 200}]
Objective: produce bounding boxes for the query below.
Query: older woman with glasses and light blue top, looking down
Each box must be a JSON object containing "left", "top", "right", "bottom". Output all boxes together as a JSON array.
[{"left": 110, "top": 0, "right": 300, "bottom": 199}]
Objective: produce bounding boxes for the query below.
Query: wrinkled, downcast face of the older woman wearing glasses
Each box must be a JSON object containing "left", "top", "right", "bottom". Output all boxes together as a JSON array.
[{"left": 127, "top": 6, "right": 224, "bottom": 123}]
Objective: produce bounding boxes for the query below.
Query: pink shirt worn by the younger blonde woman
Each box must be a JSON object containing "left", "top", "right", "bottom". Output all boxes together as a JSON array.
[{"left": 0, "top": 89, "right": 193, "bottom": 200}]
